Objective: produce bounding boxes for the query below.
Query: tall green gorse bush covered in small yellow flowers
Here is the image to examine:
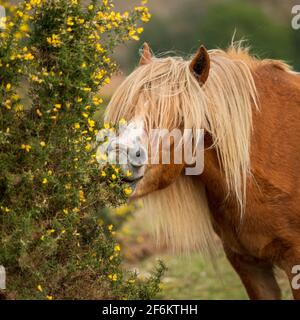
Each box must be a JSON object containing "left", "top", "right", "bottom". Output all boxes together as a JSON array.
[{"left": 0, "top": 0, "right": 164, "bottom": 299}]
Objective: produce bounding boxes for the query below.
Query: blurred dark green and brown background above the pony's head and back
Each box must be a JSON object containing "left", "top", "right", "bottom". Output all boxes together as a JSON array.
[{"left": 112, "top": 0, "right": 300, "bottom": 72}]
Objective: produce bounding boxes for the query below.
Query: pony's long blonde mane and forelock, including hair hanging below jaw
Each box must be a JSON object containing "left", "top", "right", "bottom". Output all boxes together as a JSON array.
[{"left": 106, "top": 47, "right": 257, "bottom": 254}]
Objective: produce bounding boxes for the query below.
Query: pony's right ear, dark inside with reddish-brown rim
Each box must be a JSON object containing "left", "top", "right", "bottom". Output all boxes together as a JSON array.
[{"left": 190, "top": 46, "right": 210, "bottom": 85}]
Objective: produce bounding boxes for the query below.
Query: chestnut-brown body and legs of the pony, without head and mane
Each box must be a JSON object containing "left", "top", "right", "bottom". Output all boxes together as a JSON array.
[{"left": 202, "top": 63, "right": 300, "bottom": 299}]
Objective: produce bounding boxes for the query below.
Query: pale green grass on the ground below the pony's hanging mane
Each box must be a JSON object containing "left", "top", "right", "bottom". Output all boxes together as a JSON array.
[{"left": 140, "top": 254, "right": 291, "bottom": 300}]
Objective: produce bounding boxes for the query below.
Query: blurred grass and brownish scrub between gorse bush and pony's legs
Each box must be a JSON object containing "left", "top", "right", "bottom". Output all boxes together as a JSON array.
[{"left": 123, "top": 212, "right": 291, "bottom": 300}]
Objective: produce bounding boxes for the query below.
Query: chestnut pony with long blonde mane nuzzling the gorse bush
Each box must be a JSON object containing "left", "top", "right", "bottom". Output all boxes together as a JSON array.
[{"left": 106, "top": 44, "right": 300, "bottom": 299}]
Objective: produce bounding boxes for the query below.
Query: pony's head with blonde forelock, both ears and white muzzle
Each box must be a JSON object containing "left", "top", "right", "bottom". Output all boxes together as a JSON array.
[{"left": 106, "top": 43, "right": 210, "bottom": 198}]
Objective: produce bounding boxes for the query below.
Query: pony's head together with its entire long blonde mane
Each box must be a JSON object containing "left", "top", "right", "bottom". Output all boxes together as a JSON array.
[{"left": 106, "top": 44, "right": 256, "bottom": 249}]
